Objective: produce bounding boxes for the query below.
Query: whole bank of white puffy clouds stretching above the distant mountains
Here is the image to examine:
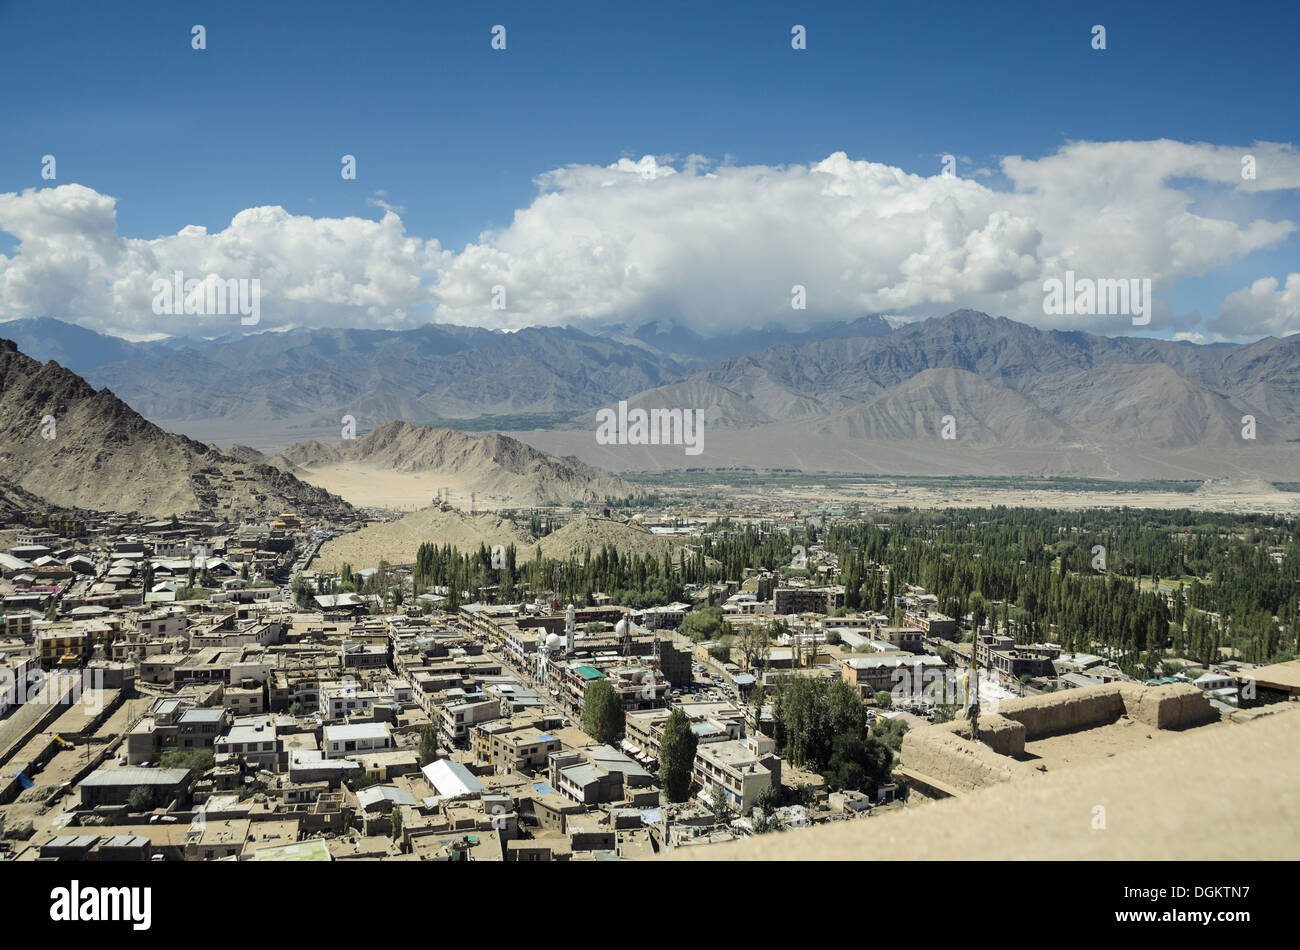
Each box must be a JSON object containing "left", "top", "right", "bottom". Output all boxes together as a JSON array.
[{"left": 0, "top": 140, "right": 1300, "bottom": 337}]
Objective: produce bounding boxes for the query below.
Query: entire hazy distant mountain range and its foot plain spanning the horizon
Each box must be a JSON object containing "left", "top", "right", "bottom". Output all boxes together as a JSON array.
[{"left": 10, "top": 311, "right": 1300, "bottom": 483}]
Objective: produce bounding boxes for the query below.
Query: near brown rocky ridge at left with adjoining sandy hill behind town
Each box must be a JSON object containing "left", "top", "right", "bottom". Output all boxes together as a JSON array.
[{"left": 0, "top": 339, "right": 633, "bottom": 522}]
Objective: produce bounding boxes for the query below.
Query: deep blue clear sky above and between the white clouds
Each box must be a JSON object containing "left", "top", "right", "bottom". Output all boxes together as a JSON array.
[{"left": 0, "top": 1, "right": 1300, "bottom": 343}]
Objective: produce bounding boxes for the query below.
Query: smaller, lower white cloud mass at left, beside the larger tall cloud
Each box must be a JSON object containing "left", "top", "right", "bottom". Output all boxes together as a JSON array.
[{"left": 0, "top": 185, "right": 450, "bottom": 338}]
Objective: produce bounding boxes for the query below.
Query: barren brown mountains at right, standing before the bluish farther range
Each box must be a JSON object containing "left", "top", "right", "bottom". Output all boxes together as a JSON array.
[{"left": 603, "top": 311, "right": 1300, "bottom": 448}]
